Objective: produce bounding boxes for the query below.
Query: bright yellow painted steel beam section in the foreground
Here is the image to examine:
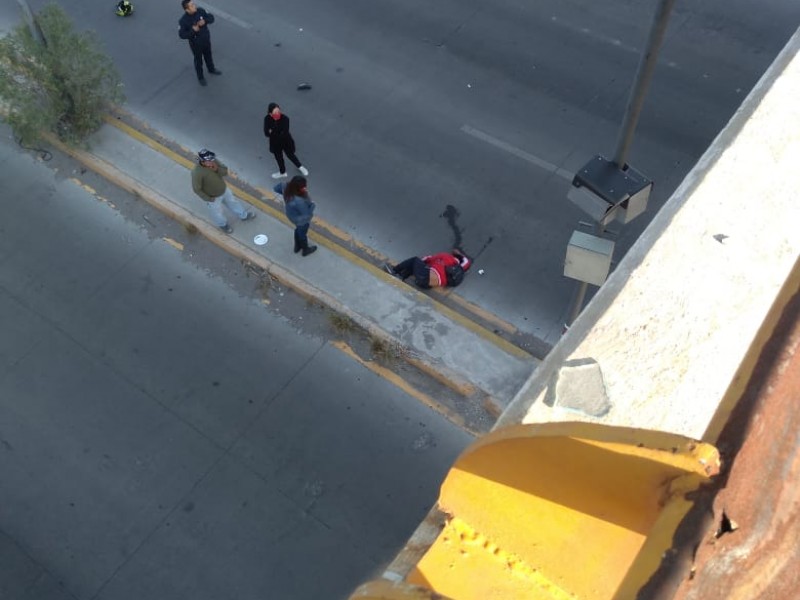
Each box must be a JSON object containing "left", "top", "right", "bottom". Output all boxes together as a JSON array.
[{"left": 407, "top": 423, "right": 719, "bottom": 600}]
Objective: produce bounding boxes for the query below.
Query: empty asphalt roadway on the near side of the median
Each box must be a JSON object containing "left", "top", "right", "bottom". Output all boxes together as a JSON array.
[{"left": 0, "top": 129, "right": 471, "bottom": 600}]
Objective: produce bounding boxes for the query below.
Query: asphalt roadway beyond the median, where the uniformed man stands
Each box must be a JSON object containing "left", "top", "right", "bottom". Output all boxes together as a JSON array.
[{"left": 4, "top": 0, "right": 800, "bottom": 342}]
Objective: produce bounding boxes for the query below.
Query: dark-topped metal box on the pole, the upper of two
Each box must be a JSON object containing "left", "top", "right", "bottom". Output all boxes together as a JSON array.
[{"left": 567, "top": 155, "right": 653, "bottom": 224}]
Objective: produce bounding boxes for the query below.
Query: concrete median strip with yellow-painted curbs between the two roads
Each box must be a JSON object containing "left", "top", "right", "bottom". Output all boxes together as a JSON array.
[{"left": 51, "top": 118, "right": 538, "bottom": 414}]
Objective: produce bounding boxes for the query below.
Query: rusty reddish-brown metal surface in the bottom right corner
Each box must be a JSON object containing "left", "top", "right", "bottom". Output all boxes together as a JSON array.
[{"left": 638, "top": 284, "right": 800, "bottom": 600}]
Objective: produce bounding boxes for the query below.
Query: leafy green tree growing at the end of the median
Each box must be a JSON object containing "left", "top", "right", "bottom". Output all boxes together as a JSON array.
[{"left": 0, "top": 4, "right": 125, "bottom": 144}]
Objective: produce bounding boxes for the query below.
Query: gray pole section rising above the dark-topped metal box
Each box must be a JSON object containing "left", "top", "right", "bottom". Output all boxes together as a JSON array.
[{"left": 612, "top": 0, "right": 675, "bottom": 169}]
